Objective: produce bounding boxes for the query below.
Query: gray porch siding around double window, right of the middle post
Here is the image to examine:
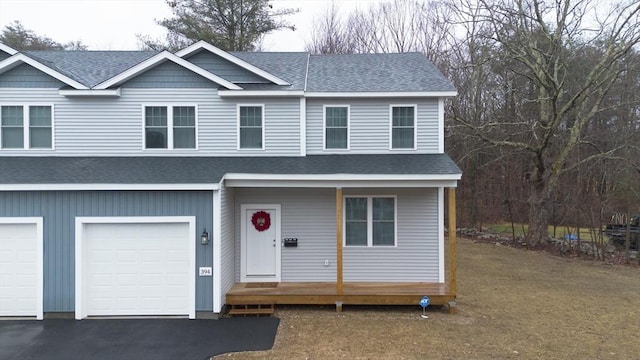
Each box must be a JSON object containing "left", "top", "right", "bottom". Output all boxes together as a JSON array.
[{"left": 343, "top": 188, "right": 439, "bottom": 282}]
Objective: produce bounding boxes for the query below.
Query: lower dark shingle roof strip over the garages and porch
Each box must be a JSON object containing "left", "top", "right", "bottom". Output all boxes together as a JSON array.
[{"left": 0, "top": 154, "right": 461, "bottom": 184}]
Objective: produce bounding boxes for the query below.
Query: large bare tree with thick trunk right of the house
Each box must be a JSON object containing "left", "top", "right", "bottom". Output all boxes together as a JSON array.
[{"left": 456, "top": 0, "right": 640, "bottom": 244}]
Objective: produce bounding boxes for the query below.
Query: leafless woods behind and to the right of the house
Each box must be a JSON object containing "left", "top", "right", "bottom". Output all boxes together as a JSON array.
[{"left": 307, "top": 0, "right": 640, "bottom": 244}]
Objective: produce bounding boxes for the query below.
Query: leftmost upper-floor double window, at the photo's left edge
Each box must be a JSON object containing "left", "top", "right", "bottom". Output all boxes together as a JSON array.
[{"left": 0, "top": 105, "right": 53, "bottom": 149}]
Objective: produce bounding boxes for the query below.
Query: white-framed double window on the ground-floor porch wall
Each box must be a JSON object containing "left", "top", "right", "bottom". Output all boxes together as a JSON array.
[{"left": 344, "top": 196, "right": 396, "bottom": 247}]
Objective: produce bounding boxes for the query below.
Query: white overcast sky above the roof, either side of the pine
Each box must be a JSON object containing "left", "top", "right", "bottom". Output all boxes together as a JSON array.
[{"left": 0, "top": 0, "right": 379, "bottom": 51}]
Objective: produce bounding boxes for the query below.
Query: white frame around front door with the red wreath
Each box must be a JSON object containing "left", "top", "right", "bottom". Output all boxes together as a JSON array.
[{"left": 240, "top": 204, "right": 282, "bottom": 282}]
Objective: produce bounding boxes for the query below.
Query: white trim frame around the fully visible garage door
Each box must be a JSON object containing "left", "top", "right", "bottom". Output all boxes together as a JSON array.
[{"left": 75, "top": 216, "right": 196, "bottom": 320}]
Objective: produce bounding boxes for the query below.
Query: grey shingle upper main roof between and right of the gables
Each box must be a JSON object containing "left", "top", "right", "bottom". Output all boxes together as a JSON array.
[{"left": 15, "top": 46, "right": 455, "bottom": 92}]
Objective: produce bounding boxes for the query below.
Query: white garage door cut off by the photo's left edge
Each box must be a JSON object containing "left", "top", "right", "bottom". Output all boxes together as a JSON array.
[{"left": 0, "top": 218, "right": 42, "bottom": 319}]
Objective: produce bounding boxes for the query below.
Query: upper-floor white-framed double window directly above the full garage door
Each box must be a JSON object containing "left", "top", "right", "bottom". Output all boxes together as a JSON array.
[{"left": 144, "top": 106, "right": 196, "bottom": 149}]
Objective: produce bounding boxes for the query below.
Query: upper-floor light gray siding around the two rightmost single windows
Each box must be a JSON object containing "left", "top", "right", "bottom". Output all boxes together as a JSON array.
[{"left": 307, "top": 98, "right": 440, "bottom": 155}]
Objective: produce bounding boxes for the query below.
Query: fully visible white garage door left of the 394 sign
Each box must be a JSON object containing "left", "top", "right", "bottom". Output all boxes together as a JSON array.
[{"left": 82, "top": 223, "right": 195, "bottom": 316}]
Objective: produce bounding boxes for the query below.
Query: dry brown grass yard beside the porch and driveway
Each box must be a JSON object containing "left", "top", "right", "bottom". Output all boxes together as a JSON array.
[{"left": 216, "top": 239, "right": 640, "bottom": 360}]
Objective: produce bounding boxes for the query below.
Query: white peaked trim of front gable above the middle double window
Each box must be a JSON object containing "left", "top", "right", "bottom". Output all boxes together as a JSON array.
[{"left": 94, "top": 51, "right": 242, "bottom": 90}]
